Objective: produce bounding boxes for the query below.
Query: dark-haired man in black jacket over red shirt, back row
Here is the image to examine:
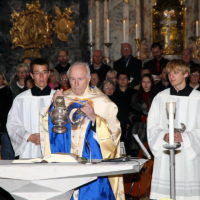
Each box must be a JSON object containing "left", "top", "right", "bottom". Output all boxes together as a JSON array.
[{"left": 144, "top": 42, "right": 168, "bottom": 80}]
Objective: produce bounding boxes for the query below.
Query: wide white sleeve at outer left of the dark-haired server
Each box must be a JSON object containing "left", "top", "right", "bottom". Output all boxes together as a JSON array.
[{"left": 6, "top": 97, "right": 31, "bottom": 156}]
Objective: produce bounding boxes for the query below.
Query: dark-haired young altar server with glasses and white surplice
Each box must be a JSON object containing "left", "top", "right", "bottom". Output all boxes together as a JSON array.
[{"left": 7, "top": 59, "right": 54, "bottom": 158}]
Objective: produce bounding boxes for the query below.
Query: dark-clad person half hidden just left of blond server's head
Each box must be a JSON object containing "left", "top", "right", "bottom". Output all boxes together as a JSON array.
[{"left": 155, "top": 67, "right": 171, "bottom": 94}]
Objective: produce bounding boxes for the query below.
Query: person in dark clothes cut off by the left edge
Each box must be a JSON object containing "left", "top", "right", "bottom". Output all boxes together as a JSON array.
[{"left": 0, "top": 72, "right": 15, "bottom": 160}]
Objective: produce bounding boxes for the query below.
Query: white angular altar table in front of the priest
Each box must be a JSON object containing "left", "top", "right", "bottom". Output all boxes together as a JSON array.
[{"left": 0, "top": 159, "right": 146, "bottom": 200}]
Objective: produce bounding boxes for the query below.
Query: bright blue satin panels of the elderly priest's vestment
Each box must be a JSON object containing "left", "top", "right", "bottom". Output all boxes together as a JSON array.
[{"left": 48, "top": 103, "right": 115, "bottom": 200}]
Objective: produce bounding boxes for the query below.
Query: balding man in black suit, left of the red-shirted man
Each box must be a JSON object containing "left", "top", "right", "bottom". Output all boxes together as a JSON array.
[{"left": 113, "top": 43, "right": 142, "bottom": 87}]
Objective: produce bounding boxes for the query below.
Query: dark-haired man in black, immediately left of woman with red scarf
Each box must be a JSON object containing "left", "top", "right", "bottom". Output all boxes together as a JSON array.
[{"left": 113, "top": 72, "right": 136, "bottom": 142}]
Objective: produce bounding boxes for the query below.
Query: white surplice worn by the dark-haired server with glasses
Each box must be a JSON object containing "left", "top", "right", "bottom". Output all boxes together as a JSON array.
[{"left": 7, "top": 89, "right": 54, "bottom": 158}]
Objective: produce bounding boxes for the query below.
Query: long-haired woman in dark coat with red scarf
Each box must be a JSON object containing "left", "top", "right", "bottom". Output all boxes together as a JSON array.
[{"left": 128, "top": 74, "right": 154, "bottom": 156}]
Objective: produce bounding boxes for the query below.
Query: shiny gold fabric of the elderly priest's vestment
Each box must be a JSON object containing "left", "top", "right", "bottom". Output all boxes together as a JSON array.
[{"left": 41, "top": 87, "right": 125, "bottom": 200}]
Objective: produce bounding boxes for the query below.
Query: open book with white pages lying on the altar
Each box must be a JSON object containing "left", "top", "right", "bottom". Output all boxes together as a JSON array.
[{"left": 12, "top": 153, "right": 82, "bottom": 163}]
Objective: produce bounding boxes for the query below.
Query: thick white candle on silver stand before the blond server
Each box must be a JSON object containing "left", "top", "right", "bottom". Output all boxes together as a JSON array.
[{"left": 168, "top": 102, "right": 175, "bottom": 145}]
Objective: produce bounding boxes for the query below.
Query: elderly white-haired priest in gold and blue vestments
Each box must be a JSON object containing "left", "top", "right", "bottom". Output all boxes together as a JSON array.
[{"left": 41, "top": 62, "right": 124, "bottom": 200}]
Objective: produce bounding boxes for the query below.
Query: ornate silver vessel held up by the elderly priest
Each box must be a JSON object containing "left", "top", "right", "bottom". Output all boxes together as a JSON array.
[{"left": 50, "top": 96, "right": 68, "bottom": 134}]
